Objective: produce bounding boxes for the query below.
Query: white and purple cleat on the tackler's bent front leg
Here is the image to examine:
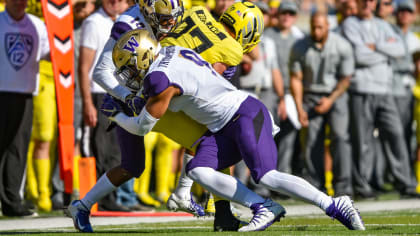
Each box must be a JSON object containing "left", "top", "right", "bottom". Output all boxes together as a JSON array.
[{"left": 238, "top": 199, "right": 286, "bottom": 232}]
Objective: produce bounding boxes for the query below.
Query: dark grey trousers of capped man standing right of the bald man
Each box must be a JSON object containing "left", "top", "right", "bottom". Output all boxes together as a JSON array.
[{"left": 351, "top": 94, "right": 415, "bottom": 198}]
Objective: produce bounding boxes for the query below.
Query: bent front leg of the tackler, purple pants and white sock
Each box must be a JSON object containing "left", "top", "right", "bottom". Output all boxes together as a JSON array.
[{"left": 187, "top": 133, "right": 285, "bottom": 231}]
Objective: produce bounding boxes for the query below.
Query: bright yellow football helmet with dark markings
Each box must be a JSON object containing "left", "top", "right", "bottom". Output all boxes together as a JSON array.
[{"left": 220, "top": 2, "right": 264, "bottom": 53}]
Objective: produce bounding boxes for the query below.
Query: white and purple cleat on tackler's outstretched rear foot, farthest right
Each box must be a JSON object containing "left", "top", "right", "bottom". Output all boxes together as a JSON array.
[{"left": 325, "top": 196, "right": 365, "bottom": 230}]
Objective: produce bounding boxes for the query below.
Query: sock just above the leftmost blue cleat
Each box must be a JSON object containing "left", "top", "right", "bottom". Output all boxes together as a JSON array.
[{"left": 80, "top": 173, "right": 117, "bottom": 210}]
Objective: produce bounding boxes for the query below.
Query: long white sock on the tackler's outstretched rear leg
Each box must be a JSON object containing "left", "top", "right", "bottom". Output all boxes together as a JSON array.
[{"left": 260, "top": 170, "right": 332, "bottom": 211}]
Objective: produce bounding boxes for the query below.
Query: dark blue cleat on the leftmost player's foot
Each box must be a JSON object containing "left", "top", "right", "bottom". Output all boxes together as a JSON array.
[{"left": 67, "top": 200, "right": 93, "bottom": 233}]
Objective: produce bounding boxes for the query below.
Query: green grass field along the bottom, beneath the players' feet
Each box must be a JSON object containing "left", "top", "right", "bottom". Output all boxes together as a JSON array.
[{"left": 0, "top": 210, "right": 420, "bottom": 236}]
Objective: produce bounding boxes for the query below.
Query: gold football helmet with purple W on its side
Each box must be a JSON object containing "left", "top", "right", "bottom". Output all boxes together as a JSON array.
[{"left": 112, "top": 29, "right": 158, "bottom": 91}]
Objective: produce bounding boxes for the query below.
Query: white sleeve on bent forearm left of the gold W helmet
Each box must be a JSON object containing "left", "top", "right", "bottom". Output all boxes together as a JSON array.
[{"left": 93, "top": 37, "right": 131, "bottom": 101}]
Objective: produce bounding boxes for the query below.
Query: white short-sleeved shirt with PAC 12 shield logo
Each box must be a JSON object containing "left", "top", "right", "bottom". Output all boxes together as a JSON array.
[{"left": 0, "top": 11, "right": 50, "bottom": 94}]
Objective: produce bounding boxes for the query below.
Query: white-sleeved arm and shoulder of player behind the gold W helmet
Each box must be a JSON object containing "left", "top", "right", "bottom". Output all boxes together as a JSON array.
[{"left": 93, "top": 4, "right": 154, "bottom": 101}]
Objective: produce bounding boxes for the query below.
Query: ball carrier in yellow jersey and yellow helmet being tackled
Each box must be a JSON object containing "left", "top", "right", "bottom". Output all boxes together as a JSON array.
[{"left": 139, "top": 0, "right": 263, "bottom": 231}]
